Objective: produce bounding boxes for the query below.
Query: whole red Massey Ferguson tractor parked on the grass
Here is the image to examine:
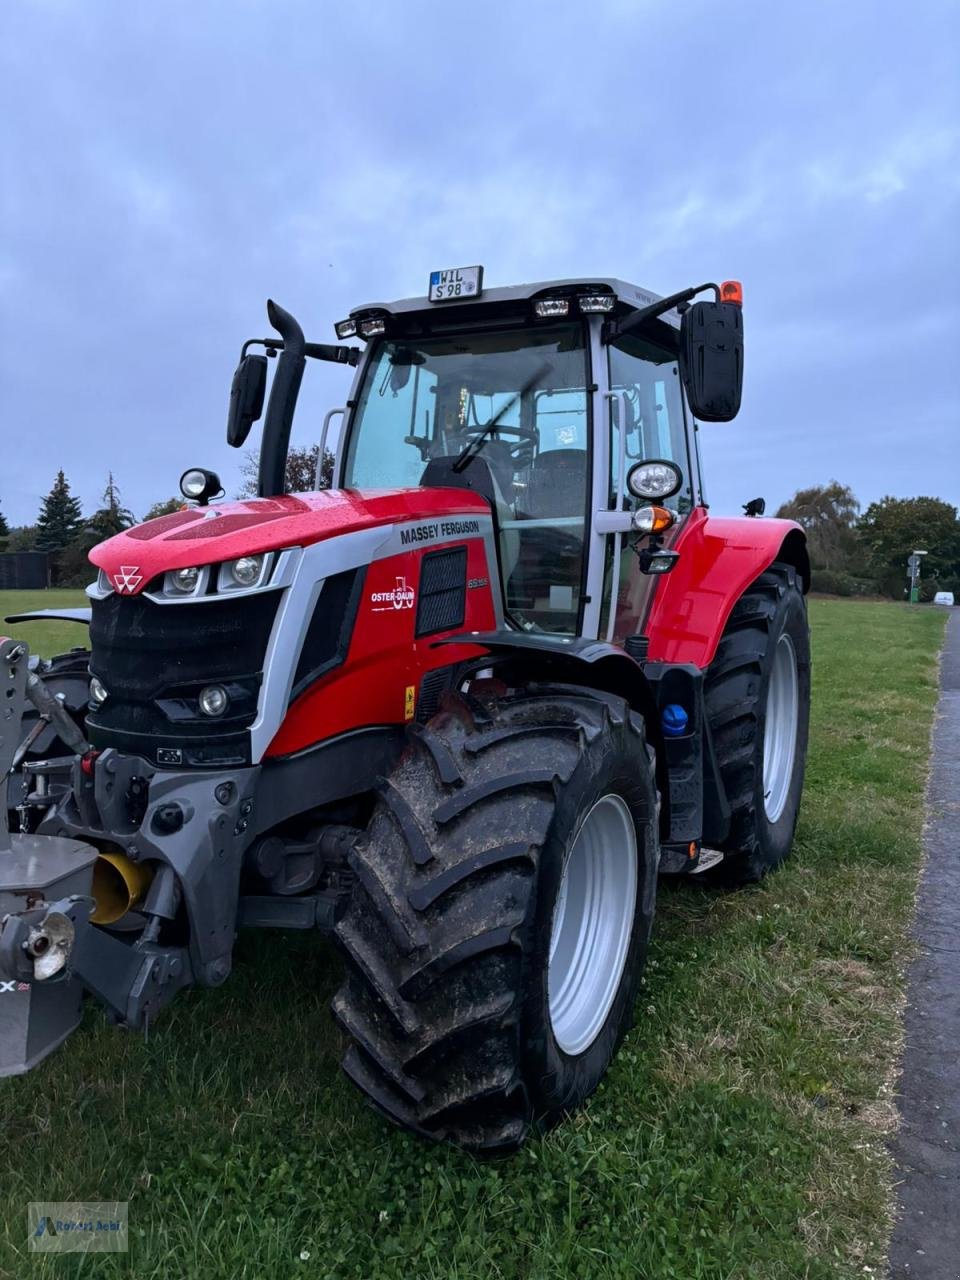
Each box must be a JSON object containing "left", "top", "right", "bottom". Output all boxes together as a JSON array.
[{"left": 0, "top": 268, "right": 810, "bottom": 1152}]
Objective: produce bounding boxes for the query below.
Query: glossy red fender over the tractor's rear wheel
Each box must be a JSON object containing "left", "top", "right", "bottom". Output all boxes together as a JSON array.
[{"left": 645, "top": 508, "right": 810, "bottom": 669}]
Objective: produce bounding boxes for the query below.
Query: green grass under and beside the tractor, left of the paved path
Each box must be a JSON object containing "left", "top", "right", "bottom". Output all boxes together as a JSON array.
[{"left": 0, "top": 598, "right": 943, "bottom": 1280}]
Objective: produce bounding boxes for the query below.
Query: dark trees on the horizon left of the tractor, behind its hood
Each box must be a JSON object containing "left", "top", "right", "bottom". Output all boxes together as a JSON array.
[{"left": 0, "top": 445, "right": 334, "bottom": 586}]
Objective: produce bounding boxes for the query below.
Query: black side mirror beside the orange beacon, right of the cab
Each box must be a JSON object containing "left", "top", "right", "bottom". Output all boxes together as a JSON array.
[{"left": 680, "top": 302, "right": 744, "bottom": 422}]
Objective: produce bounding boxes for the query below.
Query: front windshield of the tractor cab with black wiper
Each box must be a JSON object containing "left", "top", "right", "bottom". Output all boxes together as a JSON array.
[{"left": 343, "top": 323, "right": 590, "bottom": 635}]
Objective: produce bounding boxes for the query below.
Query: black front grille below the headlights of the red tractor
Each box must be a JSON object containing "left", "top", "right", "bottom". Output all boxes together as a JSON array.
[{"left": 87, "top": 591, "right": 280, "bottom": 767}]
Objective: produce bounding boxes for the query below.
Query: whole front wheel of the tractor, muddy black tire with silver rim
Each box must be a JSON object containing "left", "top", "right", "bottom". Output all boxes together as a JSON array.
[{"left": 333, "top": 686, "right": 658, "bottom": 1155}]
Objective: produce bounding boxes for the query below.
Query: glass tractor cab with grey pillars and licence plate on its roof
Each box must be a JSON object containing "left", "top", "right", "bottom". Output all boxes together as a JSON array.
[{"left": 334, "top": 275, "right": 742, "bottom": 637}]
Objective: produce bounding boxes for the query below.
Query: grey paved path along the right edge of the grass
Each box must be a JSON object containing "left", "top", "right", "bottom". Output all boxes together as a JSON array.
[{"left": 890, "top": 609, "right": 960, "bottom": 1280}]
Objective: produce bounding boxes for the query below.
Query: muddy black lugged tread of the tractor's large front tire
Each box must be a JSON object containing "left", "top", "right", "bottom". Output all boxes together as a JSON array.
[{"left": 333, "top": 686, "right": 657, "bottom": 1155}]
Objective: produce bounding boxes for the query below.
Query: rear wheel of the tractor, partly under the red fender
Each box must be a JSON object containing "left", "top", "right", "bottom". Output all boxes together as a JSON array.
[{"left": 704, "top": 563, "right": 810, "bottom": 884}]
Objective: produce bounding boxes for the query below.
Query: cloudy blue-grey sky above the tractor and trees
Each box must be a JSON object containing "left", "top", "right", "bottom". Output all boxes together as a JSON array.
[{"left": 0, "top": 0, "right": 960, "bottom": 525}]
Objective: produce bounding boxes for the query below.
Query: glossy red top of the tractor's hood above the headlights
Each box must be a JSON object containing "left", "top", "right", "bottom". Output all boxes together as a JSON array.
[{"left": 90, "top": 489, "right": 489, "bottom": 595}]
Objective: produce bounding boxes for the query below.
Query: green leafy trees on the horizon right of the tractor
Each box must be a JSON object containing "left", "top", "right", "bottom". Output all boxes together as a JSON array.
[{"left": 777, "top": 480, "right": 960, "bottom": 600}]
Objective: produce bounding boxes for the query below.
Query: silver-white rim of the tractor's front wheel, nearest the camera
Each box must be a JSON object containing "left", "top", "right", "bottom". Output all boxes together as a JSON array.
[{"left": 547, "top": 794, "right": 637, "bottom": 1057}]
